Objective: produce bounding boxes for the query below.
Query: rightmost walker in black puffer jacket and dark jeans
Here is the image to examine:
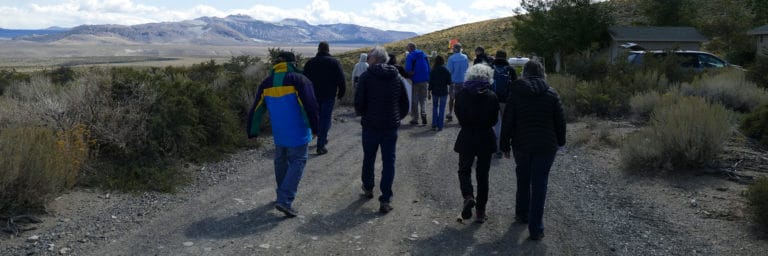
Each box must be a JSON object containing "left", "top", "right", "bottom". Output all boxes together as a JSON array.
[{"left": 500, "top": 60, "right": 565, "bottom": 240}]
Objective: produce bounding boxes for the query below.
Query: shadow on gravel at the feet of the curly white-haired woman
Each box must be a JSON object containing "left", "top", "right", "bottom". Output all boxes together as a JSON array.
[{"left": 412, "top": 223, "right": 480, "bottom": 255}]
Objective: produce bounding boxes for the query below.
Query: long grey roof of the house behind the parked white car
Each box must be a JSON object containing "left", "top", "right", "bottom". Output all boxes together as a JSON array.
[{"left": 608, "top": 26, "right": 707, "bottom": 42}]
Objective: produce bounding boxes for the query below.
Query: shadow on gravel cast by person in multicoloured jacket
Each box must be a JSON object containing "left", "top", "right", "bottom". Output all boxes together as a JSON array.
[{"left": 184, "top": 204, "right": 284, "bottom": 239}]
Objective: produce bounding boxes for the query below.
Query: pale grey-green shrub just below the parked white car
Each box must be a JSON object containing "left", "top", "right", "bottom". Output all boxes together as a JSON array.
[{"left": 680, "top": 70, "right": 768, "bottom": 112}]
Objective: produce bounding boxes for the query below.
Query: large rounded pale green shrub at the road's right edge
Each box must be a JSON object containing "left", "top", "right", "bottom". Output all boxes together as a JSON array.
[{"left": 621, "top": 97, "right": 731, "bottom": 169}]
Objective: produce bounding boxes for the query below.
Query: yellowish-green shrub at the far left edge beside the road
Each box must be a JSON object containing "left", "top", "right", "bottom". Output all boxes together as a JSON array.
[{"left": 0, "top": 125, "right": 88, "bottom": 213}]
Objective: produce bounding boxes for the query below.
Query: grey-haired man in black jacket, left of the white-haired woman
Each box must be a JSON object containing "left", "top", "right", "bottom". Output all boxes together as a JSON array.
[{"left": 355, "top": 46, "right": 410, "bottom": 213}]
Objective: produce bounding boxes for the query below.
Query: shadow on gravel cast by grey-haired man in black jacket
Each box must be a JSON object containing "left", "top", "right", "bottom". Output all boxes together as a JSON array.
[{"left": 298, "top": 197, "right": 378, "bottom": 235}]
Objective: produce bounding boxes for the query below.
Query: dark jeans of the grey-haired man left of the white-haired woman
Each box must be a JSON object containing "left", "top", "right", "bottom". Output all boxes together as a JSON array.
[{"left": 362, "top": 128, "right": 397, "bottom": 202}]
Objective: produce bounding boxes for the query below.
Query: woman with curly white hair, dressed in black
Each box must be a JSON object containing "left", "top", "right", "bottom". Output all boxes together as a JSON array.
[{"left": 453, "top": 64, "right": 499, "bottom": 223}]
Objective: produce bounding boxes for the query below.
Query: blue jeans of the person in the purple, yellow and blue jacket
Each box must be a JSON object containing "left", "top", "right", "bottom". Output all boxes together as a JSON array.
[{"left": 275, "top": 144, "right": 309, "bottom": 208}]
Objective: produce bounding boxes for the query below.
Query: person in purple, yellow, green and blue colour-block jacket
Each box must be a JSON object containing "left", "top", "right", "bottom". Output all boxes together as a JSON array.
[{"left": 247, "top": 52, "right": 318, "bottom": 218}]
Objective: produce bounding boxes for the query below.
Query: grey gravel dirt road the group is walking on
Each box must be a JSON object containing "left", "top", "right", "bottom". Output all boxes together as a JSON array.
[{"left": 0, "top": 108, "right": 768, "bottom": 255}]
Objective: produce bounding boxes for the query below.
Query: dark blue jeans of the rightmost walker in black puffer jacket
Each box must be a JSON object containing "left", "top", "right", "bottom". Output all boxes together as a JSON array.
[{"left": 514, "top": 150, "right": 557, "bottom": 234}]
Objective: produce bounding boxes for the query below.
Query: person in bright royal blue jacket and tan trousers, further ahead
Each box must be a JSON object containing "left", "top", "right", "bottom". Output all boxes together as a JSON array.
[{"left": 405, "top": 43, "right": 430, "bottom": 124}]
